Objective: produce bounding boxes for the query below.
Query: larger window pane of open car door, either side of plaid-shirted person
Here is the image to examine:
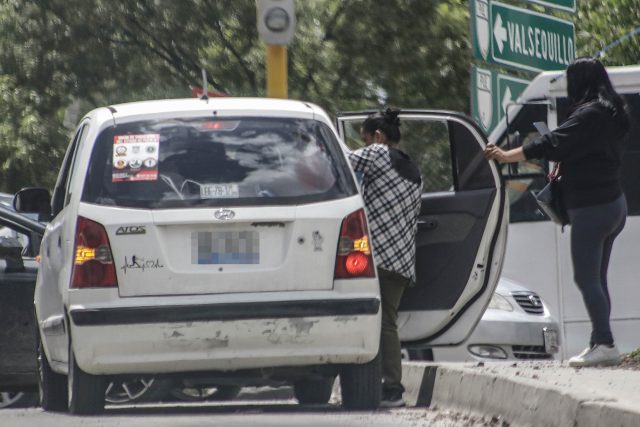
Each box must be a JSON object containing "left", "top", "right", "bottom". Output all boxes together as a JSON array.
[{"left": 344, "top": 117, "right": 454, "bottom": 193}]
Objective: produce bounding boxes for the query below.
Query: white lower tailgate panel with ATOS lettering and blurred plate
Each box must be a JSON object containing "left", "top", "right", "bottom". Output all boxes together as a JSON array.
[{"left": 106, "top": 202, "right": 343, "bottom": 297}]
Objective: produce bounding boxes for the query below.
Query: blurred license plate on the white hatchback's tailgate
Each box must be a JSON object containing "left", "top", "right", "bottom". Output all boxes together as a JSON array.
[{"left": 191, "top": 231, "right": 260, "bottom": 264}]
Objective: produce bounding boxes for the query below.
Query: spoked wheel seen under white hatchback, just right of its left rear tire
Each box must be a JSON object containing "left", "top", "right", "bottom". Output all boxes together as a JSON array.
[{"left": 105, "top": 377, "right": 173, "bottom": 404}]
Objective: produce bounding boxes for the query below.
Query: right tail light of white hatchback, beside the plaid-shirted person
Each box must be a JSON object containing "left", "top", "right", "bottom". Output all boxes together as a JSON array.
[{"left": 333, "top": 209, "right": 375, "bottom": 279}]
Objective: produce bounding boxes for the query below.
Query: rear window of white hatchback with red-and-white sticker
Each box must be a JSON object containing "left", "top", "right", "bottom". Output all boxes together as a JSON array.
[{"left": 82, "top": 117, "right": 357, "bottom": 209}]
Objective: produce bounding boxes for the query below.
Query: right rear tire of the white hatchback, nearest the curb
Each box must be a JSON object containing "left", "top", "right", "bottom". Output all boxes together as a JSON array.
[{"left": 340, "top": 353, "right": 382, "bottom": 411}]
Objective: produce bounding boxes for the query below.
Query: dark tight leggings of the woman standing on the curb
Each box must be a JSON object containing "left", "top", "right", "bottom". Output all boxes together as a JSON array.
[{"left": 569, "top": 196, "right": 627, "bottom": 346}]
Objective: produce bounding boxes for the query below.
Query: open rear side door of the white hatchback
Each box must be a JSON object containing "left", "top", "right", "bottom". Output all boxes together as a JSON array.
[{"left": 337, "top": 110, "right": 508, "bottom": 347}]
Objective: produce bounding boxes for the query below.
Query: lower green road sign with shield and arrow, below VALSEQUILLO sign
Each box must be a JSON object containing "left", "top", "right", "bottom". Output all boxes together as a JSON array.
[{"left": 471, "top": 67, "right": 529, "bottom": 135}]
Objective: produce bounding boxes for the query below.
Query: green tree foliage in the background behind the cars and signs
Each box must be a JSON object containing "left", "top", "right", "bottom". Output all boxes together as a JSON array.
[{"left": 0, "top": 0, "right": 640, "bottom": 191}]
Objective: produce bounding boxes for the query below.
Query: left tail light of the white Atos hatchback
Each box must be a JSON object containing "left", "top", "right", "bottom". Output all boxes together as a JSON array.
[{"left": 71, "top": 216, "right": 118, "bottom": 288}]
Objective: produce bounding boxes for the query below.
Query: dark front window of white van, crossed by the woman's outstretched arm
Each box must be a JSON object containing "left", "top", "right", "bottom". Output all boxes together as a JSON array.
[{"left": 497, "top": 103, "right": 548, "bottom": 222}]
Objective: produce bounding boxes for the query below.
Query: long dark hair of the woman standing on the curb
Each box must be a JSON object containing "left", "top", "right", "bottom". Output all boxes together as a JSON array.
[{"left": 567, "top": 57, "right": 629, "bottom": 124}]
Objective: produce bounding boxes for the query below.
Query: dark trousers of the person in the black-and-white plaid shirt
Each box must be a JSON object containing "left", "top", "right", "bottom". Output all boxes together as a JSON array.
[{"left": 378, "top": 268, "right": 409, "bottom": 392}]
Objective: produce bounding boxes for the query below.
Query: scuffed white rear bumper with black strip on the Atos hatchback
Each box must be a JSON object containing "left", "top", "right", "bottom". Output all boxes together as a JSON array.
[{"left": 69, "top": 298, "right": 380, "bottom": 375}]
